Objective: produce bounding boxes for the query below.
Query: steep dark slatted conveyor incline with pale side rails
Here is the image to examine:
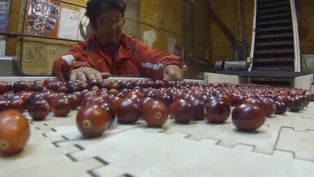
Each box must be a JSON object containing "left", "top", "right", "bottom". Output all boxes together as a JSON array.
[{"left": 250, "top": 0, "right": 300, "bottom": 86}]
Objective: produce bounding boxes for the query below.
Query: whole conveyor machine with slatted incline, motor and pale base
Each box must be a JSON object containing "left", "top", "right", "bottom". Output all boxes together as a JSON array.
[{"left": 209, "top": 0, "right": 313, "bottom": 90}]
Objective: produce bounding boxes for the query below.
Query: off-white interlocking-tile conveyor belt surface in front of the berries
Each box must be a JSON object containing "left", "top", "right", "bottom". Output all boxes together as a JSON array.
[{"left": 0, "top": 104, "right": 314, "bottom": 177}]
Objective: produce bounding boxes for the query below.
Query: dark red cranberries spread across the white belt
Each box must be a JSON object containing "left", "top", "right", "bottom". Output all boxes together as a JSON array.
[{"left": 0, "top": 79, "right": 314, "bottom": 154}]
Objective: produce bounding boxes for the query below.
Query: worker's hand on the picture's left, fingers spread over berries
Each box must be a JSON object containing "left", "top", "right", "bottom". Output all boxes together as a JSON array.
[{"left": 70, "top": 67, "right": 110, "bottom": 83}]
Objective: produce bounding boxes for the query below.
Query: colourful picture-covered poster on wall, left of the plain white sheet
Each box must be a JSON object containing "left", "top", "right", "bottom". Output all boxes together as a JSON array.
[{"left": 25, "top": 0, "right": 60, "bottom": 37}]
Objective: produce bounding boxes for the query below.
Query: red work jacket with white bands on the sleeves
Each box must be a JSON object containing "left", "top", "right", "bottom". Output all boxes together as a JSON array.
[{"left": 52, "top": 34, "right": 185, "bottom": 80}]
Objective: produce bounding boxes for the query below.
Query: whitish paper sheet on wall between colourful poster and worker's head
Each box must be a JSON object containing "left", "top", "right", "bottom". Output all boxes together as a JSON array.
[{"left": 58, "top": 8, "right": 80, "bottom": 40}]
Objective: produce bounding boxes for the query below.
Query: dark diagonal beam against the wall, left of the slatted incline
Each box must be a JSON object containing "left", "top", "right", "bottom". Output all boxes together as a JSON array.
[{"left": 208, "top": 6, "right": 236, "bottom": 45}]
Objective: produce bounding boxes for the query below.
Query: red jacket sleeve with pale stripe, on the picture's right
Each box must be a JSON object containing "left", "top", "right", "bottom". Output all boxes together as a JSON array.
[{"left": 135, "top": 41, "right": 186, "bottom": 80}]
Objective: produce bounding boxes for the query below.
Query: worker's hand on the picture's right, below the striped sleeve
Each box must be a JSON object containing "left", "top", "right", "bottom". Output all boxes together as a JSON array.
[{"left": 163, "top": 65, "right": 184, "bottom": 81}]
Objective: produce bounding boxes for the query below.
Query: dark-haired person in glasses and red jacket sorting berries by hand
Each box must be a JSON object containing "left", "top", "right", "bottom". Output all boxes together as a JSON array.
[{"left": 52, "top": 0, "right": 186, "bottom": 81}]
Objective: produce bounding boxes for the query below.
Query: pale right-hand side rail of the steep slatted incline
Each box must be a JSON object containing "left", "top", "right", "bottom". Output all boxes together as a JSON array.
[{"left": 290, "top": 0, "right": 301, "bottom": 72}]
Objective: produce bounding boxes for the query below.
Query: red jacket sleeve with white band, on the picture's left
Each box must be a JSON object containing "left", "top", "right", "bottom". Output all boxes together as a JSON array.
[{"left": 52, "top": 43, "right": 92, "bottom": 80}]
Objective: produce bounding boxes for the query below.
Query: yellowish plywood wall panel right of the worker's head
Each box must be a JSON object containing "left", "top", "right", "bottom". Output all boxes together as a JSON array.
[{"left": 141, "top": 0, "right": 183, "bottom": 50}]
